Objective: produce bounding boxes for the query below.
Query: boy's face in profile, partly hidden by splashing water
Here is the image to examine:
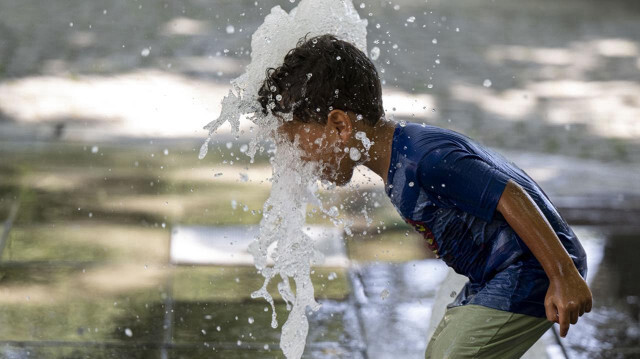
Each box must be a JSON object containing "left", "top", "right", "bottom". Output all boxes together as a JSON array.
[{"left": 278, "top": 119, "right": 356, "bottom": 186}]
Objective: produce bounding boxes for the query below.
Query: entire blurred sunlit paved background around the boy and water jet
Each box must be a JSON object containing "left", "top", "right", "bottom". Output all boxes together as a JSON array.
[{"left": 0, "top": 0, "right": 640, "bottom": 358}]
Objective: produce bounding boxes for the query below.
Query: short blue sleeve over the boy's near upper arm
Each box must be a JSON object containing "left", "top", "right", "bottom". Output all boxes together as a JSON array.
[{"left": 418, "top": 146, "right": 509, "bottom": 222}]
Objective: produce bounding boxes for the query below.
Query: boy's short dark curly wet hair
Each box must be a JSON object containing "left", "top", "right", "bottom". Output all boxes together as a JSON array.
[{"left": 258, "top": 35, "right": 384, "bottom": 126}]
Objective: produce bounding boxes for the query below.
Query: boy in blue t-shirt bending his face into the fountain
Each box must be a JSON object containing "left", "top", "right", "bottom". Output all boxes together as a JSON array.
[{"left": 259, "top": 35, "right": 592, "bottom": 358}]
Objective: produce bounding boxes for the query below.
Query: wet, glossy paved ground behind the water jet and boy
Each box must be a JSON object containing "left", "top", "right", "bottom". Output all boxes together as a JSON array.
[{"left": 0, "top": 143, "right": 640, "bottom": 359}]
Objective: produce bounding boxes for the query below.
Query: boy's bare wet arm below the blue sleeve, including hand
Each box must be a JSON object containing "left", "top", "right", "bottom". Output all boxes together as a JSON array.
[{"left": 497, "top": 180, "right": 592, "bottom": 337}]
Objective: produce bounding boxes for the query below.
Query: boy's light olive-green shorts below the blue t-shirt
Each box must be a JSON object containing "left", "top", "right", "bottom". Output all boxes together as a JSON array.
[{"left": 425, "top": 304, "right": 553, "bottom": 359}]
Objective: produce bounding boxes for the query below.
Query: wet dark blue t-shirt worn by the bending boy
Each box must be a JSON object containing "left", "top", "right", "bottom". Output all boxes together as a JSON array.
[{"left": 385, "top": 123, "right": 587, "bottom": 318}]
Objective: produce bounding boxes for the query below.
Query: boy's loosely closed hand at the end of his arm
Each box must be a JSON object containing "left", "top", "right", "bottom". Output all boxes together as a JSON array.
[{"left": 544, "top": 271, "right": 592, "bottom": 338}]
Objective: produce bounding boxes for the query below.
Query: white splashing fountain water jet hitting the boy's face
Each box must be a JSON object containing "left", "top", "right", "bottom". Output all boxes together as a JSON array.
[{"left": 198, "top": 0, "right": 368, "bottom": 359}]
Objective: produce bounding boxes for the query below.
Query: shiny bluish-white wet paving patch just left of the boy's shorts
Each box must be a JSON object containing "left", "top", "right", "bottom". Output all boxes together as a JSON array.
[{"left": 351, "top": 259, "right": 447, "bottom": 359}]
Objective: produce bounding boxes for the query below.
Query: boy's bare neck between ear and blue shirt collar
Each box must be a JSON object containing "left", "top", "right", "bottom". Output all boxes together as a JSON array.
[{"left": 364, "top": 119, "right": 396, "bottom": 187}]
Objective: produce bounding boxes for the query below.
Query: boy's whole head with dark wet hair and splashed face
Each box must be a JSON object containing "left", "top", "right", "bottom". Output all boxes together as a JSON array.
[{"left": 258, "top": 35, "right": 384, "bottom": 185}]
